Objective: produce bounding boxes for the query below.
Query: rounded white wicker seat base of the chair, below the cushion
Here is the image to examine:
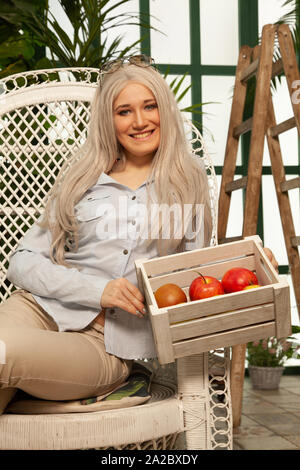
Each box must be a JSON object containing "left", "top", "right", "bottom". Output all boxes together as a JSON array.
[{"left": 0, "top": 383, "right": 184, "bottom": 450}]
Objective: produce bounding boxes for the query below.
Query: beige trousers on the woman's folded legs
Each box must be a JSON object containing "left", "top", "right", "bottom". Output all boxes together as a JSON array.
[{"left": 0, "top": 290, "right": 132, "bottom": 414}]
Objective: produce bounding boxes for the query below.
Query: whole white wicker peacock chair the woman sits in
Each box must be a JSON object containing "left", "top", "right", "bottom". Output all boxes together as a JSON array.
[{"left": 0, "top": 68, "right": 232, "bottom": 449}]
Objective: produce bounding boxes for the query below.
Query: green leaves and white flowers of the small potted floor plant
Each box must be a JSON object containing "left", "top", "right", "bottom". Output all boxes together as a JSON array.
[{"left": 247, "top": 326, "right": 300, "bottom": 367}]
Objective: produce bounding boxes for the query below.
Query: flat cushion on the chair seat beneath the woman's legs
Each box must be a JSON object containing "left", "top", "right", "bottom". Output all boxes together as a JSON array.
[{"left": 5, "top": 363, "right": 153, "bottom": 414}]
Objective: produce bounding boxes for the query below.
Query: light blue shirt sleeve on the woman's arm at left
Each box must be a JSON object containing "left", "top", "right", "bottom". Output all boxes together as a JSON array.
[{"left": 7, "top": 216, "right": 110, "bottom": 308}]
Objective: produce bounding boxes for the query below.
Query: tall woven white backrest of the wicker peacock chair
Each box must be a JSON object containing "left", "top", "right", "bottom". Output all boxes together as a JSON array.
[{"left": 0, "top": 68, "right": 218, "bottom": 301}]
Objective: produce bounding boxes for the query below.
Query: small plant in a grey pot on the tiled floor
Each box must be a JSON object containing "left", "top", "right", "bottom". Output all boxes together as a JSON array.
[{"left": 247, "top": 326, "right": 300, "bottom": 390}]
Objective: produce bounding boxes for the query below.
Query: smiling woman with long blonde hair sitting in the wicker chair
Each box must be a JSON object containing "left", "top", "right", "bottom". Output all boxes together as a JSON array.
[{"left": 0, "top": 56, "right": 278, "bottom": 412}]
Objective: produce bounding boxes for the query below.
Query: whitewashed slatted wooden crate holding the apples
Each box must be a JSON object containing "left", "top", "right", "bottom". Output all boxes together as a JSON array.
[{"left": 135, "top": 236, "right": 291, "bottom": 364}]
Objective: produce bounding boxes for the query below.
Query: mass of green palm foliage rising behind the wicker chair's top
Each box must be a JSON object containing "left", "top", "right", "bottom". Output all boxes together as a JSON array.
[{"left": 0, "top": 0, "right": 153, "bottom": 77}]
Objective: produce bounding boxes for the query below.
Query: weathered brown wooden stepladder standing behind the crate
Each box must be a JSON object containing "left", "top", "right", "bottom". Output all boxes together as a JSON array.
[{"left": 218, "top": 25, "right": 300, "bottom": 427}]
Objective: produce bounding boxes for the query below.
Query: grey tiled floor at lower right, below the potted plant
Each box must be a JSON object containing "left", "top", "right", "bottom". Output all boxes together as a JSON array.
[{"left": 233, "top": 375, "right": 300, "bottom": 450}]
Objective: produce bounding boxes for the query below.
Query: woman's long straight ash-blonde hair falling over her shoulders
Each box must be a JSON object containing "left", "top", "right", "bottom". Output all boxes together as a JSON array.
[{"left": 40, "top": 64, "right": 212, "bottom": 266}]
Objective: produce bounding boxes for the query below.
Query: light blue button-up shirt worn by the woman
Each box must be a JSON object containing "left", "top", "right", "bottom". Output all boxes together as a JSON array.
[{"left": 7, "top": 173, "right": 204, "bottom": 359}]
